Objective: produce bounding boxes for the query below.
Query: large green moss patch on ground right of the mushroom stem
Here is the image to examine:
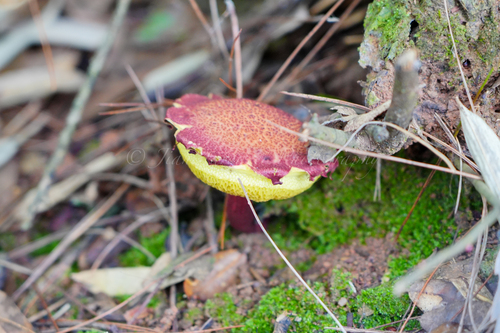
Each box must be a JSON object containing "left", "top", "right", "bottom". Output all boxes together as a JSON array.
[{"left": 269, "top": 152, "right": 456, "bottom": 277}]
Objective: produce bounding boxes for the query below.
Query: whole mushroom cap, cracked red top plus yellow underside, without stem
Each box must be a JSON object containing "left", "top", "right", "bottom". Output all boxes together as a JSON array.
[{"left": 165, "top": 94, "right": 338, "bottom": 228}]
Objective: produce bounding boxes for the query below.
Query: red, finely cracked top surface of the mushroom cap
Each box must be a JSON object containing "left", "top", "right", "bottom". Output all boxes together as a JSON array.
[{"left": 166, "top": 94, "right": 338, "bottom": 201}]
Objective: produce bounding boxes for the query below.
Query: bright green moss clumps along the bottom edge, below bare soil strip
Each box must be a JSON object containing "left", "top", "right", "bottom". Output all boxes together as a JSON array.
[{"left": 237, "top": 270, "right": 417, "bottom": 332}]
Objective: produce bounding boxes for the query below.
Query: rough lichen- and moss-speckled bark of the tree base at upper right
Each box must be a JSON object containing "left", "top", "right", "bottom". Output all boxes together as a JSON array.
[{"left": 359, "top": 0, "right": 500, "bottom": 139}]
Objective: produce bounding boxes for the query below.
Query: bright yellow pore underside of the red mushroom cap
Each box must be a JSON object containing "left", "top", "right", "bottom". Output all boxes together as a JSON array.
[{"left": 177, "top": 143, "right": 320, "bottom": 202}]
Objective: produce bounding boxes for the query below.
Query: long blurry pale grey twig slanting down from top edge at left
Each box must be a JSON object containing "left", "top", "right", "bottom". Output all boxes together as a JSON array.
[{"left": 22, "top": 0, "right": 131, "bottom": 229}]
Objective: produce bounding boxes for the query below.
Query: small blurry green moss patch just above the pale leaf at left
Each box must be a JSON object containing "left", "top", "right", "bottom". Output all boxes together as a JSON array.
[{"left": 119, "top": 228, "right": 169, "bottom": 267}]
